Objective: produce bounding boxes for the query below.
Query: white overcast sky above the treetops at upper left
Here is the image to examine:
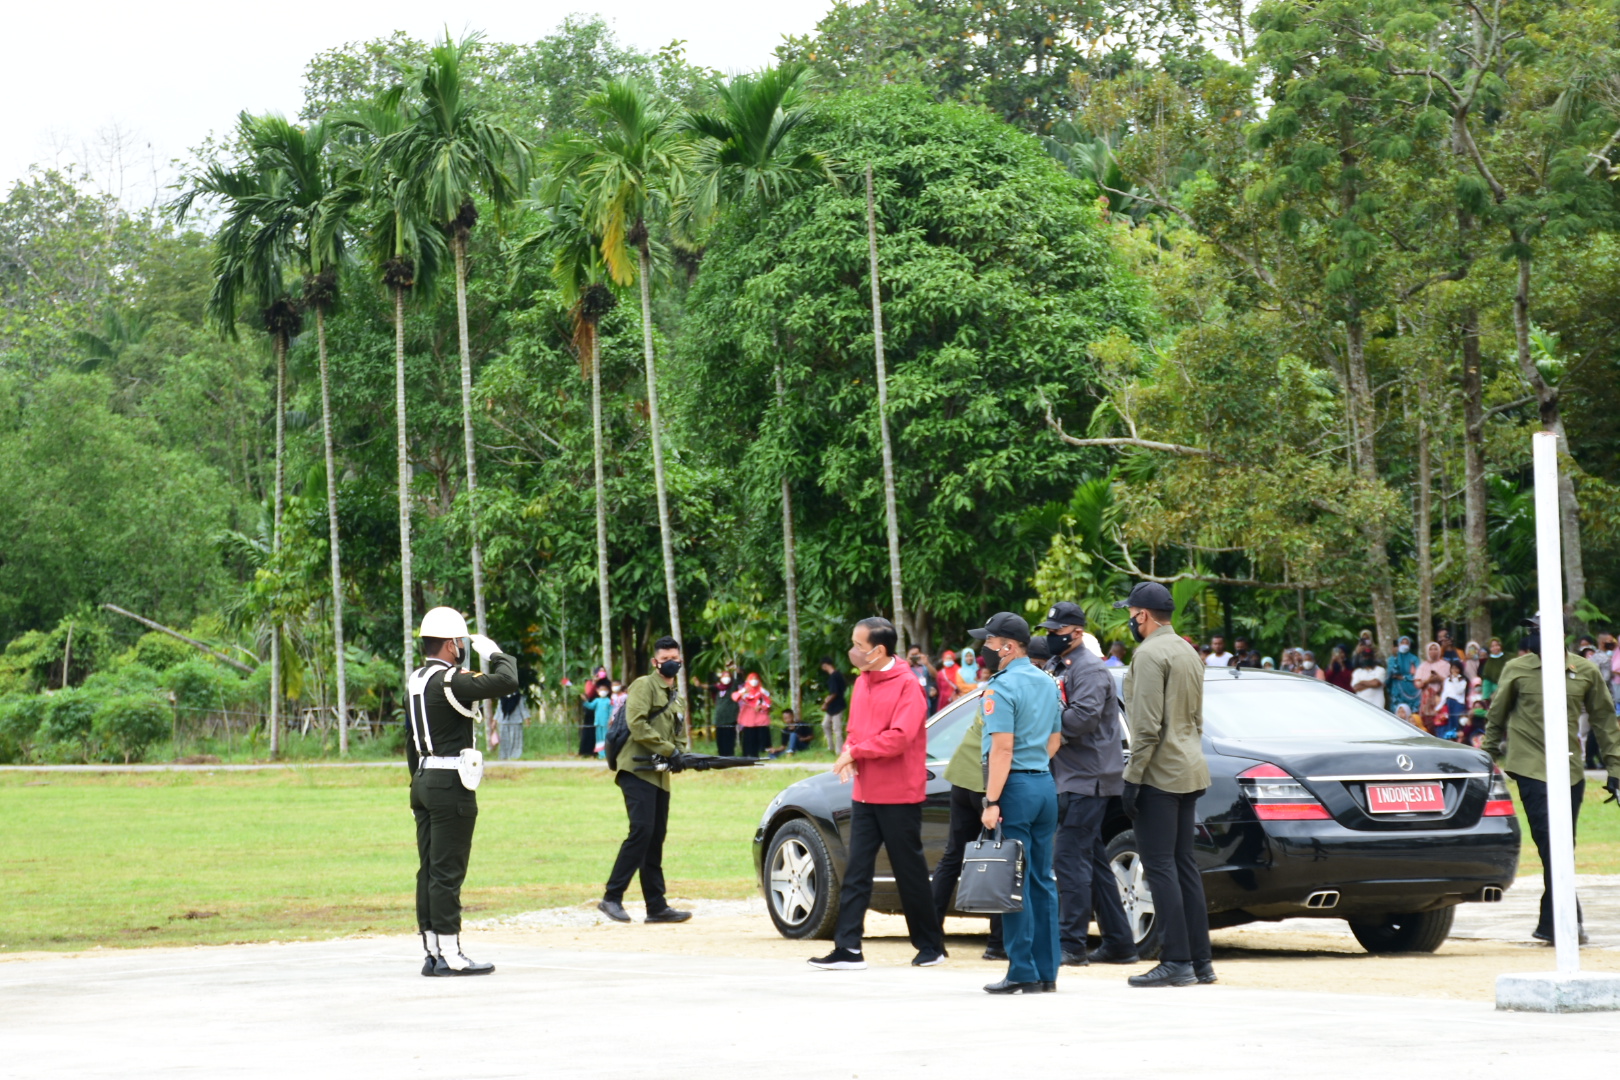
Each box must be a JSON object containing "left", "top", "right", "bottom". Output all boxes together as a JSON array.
[{"left": 0, "top": 0, "right": 831, "bottom": 204}]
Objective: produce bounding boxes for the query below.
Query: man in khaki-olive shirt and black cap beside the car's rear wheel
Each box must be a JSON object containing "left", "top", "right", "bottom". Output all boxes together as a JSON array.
[{"left": 1115, "top": 581, "right": 1215, "bottom": 986}]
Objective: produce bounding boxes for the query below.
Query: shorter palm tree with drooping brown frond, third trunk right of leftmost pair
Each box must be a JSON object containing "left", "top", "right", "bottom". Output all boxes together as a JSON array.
[{"left": 523, "top": 185, "right": 629, "bottom": 674}]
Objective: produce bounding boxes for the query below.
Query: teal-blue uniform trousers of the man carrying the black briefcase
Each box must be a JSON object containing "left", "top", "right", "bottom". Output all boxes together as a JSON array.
[{"left": 1001, "top": 772, "right": 1059, "bottom": 983}]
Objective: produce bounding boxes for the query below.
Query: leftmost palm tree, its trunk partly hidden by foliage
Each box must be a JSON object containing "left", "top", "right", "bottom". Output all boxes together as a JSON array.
[{"left": 170, "top": 128, "right": 303, "bottom": 756}]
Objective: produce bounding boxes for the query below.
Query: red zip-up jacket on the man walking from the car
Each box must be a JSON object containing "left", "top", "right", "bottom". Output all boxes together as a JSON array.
[{"left": 844, "top": 661, "right": 928, "bottom": 805}]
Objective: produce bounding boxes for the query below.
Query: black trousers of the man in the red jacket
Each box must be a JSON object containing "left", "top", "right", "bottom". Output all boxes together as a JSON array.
[{"left": 833, "top": 803, "right": 944, "bottom": 952}]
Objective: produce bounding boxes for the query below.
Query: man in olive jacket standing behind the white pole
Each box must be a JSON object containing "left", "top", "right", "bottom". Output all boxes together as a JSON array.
[{"left": 1482, "top": 619, "right": 1620, "bottom": 944}]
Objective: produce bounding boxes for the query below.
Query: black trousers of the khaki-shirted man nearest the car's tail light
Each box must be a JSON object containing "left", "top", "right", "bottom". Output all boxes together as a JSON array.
[{"left": 1136, "top": 784, "right": 1210, "bottom": 963}]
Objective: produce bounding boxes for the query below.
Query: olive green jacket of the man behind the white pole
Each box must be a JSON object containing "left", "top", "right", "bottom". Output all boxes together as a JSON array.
[{"left": 1481, "top": 653, "right": 1620, "bottom": 787}]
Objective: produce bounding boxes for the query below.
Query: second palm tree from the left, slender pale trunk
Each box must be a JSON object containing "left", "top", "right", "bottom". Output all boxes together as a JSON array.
[{"left": 246, "top": 115, "right": 363, "bottom": 755}]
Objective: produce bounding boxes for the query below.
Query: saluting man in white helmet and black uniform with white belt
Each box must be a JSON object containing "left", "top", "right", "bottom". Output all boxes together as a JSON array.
[{"left": 405, "top": 607, "right": 518, "bottom": 975}]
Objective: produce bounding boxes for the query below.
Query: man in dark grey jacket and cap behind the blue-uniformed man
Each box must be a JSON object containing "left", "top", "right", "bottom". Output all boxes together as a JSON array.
[{"left": 1042, "top": 601, "right": 1136, "bottom": 967}]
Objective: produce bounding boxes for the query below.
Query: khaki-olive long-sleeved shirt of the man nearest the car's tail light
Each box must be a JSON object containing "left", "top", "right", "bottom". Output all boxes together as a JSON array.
[{"left": 1124, "top": 627, "right": 1210, "bottom": 795}]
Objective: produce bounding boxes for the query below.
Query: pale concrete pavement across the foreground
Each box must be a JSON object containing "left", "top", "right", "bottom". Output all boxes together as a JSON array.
[{"left": 0, "top": 938, "right": 1620, "bottom": 1080}]
